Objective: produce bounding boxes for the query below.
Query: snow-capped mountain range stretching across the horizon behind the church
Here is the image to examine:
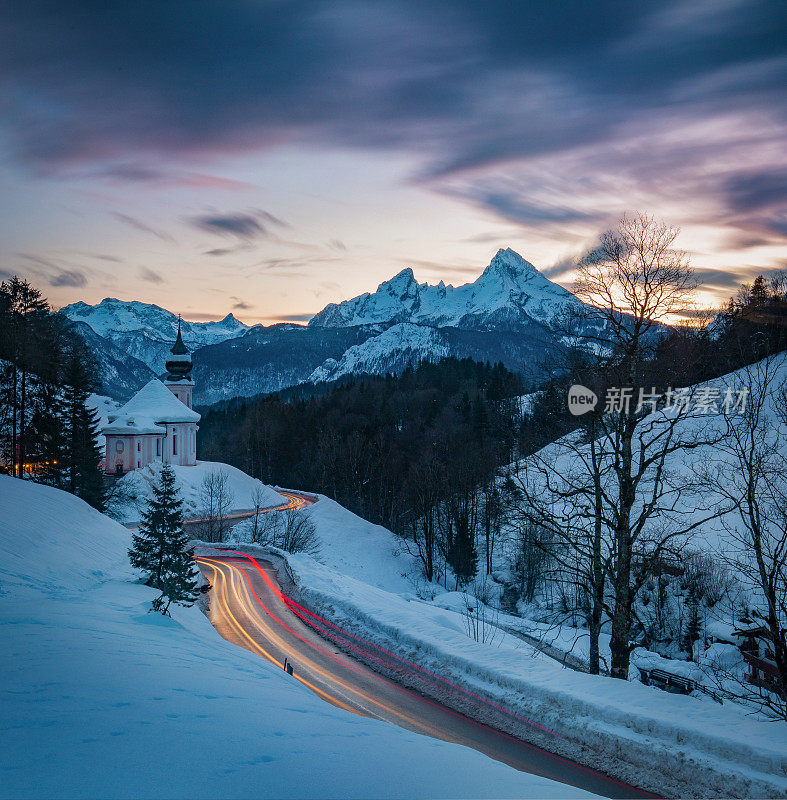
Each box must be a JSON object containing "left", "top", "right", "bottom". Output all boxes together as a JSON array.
[{"left": 61, "top": 249, "right": 596, "bottom": 404}]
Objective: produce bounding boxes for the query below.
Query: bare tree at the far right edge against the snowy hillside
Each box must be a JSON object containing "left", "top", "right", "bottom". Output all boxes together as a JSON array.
[{"left": 707, "top": 353, "right": 787, "bottom": 719}]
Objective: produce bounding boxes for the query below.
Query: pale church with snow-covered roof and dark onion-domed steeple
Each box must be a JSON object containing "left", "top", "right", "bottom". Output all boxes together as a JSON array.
[{"left": 101, "top": 321, "right": 200, "bottom": 475}]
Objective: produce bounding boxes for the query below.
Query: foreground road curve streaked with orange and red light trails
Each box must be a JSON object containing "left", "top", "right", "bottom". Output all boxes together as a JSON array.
[{"left": 196, "top": 540, "right": 653, "bottom": 798}]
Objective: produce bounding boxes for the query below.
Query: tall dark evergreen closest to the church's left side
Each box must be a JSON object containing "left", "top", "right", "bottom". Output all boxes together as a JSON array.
[{"left": 63, "top": 346, "right": 106, "bottom": 511}]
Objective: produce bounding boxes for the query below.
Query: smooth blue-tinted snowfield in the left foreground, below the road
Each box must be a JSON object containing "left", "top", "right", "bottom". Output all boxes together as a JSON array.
[{"left": 0, "top": 476, "right": 589, "bottom": 798}]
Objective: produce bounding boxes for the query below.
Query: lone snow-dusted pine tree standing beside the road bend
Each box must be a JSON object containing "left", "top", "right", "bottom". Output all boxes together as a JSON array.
[{"left": 128, "top": 464, "right": 204, "bottom": 614}]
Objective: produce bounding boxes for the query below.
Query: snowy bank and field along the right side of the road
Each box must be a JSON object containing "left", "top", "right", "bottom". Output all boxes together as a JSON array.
[{"left": 229, "top": 490, "right": 787, "bottom": 797}]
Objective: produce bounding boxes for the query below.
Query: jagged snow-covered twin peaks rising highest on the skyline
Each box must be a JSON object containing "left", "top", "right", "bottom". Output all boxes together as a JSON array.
[{"left": 309, "top": 249, "right": 579, "bottom": 328}]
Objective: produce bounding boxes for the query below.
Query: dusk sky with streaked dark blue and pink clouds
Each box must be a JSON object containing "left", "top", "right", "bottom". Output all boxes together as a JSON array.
[{"left": 0, "top": 0, "right": 787, "bottom": 322}]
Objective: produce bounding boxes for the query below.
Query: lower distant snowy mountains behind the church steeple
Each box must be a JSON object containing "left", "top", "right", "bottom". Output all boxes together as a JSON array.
[{"left": 60, "top": 297, "right": 249, "bottom": 374}]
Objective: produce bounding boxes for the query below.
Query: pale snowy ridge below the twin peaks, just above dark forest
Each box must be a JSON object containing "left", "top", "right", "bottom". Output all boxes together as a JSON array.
[{"left": 309, "top": 322, "right": 451, "bottom": 383}]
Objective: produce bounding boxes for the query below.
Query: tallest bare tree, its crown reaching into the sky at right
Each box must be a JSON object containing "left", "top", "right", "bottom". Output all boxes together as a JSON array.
[{"left": 515, "top": 214, "right": 728, "bottom": 679}]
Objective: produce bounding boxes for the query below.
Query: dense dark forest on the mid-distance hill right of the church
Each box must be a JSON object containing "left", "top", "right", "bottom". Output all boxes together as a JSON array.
[{"left": 199, "top": 358, "right": 524, "bottom": 571}]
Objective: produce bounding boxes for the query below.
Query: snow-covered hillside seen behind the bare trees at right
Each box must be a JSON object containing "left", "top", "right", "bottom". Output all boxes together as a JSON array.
[{"left": 511, "top": 352, "right": 787, "bottom": 553}]
